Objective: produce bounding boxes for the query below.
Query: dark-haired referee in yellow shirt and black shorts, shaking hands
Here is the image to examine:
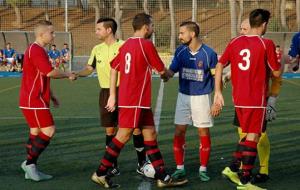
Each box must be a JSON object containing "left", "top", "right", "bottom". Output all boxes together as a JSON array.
[{"left": 77, "top": 18, "right": 146, "bottom": 175}]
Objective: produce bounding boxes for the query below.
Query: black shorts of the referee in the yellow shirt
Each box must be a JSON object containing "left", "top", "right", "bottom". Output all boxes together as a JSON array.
[{"left": 99, "top": 88, "right": 118, "bottom": 127}]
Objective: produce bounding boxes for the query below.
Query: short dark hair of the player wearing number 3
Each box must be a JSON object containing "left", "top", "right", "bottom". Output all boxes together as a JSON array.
[{"left": 249, "top": 9, "right": 271, "bottom": 28}]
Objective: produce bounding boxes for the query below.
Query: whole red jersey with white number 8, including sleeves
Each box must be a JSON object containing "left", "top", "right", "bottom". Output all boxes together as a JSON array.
[{"left": 111, "top": 37, "right": 164, "bottom": 108}]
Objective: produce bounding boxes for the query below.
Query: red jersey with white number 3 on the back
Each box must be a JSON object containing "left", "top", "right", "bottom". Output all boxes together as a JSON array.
[{"left": 219, "top": 35, "right": 280, "bottom": 108}]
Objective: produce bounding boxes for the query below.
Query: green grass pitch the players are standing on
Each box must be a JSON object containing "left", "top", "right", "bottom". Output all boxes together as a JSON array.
[{"left": 0, "top": 78, "right": 300, "bottom": 190}]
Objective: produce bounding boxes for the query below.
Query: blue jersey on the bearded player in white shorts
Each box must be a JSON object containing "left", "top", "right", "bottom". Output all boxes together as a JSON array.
[{"left": 170, "top": 44, "right": 218, "bottom": 95}]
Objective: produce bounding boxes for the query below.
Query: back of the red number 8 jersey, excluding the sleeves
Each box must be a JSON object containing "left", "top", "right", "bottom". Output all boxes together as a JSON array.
[{"left": 119, "top": 38, "right": 151, "bottom": 107}]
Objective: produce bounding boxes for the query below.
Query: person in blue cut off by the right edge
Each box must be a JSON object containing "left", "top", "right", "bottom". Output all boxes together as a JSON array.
[{"left": 288, "top": 32, "right": 300, "bottom": 72}]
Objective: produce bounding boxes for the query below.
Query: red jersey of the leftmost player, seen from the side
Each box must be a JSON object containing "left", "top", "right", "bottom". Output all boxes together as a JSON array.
[{"left": 20, "top": 43, "right": 52, "bottom": 109}]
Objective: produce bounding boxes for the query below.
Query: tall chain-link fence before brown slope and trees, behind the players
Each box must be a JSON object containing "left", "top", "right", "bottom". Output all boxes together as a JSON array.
[{"left": 0, "top": 0, "right": 297, "bottom": 56}]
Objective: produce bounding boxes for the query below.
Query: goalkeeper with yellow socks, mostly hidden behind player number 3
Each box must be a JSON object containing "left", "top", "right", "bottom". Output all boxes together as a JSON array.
[{"left": 222, "top": 19, "right": 282, "bottom": 183}]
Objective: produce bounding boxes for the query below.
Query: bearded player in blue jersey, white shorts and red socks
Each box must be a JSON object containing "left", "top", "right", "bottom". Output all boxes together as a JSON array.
[{"left": 164, "top": 21, "right": 218, "bottom": 181}]
